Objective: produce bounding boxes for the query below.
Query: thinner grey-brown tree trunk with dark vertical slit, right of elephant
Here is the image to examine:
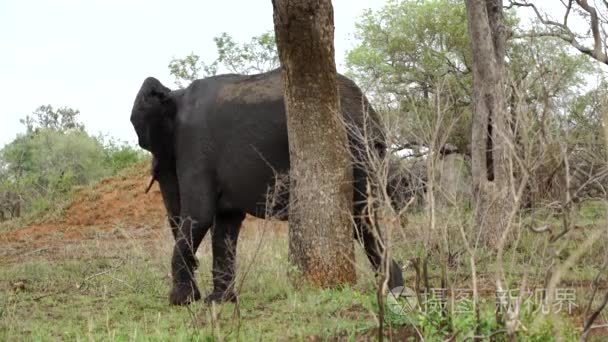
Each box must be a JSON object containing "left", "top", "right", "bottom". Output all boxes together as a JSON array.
[{"left": 466, "top": 0, "right": 514, "bottom": 245}]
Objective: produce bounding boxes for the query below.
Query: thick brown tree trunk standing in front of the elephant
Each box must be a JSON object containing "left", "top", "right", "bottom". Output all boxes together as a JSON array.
[{"left": 272, "top": 0, "right": 356, "bottom": 286}]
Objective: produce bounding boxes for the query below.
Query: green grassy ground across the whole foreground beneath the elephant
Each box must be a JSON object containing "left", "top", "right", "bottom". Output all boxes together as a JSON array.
[{"left": 0, "top": 200, "right": 608, "bottom": 341}]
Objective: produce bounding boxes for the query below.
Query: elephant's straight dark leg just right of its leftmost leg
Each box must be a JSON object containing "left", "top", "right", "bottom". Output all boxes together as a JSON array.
[{"left": 205, "top": 212, "right": 245, "bottom": 303}]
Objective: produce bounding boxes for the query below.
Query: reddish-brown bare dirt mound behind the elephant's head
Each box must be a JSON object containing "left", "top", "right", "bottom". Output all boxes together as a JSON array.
[{"left": 0, "top": 161, "right": 285, "bottom": 243}]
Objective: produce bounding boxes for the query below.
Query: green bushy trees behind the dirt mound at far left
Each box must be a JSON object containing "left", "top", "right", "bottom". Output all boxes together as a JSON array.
[{"left": 0, "top": 105, "right": 144, "bottom": 216}]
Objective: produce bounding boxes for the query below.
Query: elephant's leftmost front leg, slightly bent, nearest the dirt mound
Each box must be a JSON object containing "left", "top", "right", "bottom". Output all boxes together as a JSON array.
[{"left": 169, "top": 177, "right": 215, "bottom": 305}]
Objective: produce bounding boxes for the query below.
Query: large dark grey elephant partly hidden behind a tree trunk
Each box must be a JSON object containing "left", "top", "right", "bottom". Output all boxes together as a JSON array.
[{"left": 130, "top": 68, "right": 403, "bottom": 305}]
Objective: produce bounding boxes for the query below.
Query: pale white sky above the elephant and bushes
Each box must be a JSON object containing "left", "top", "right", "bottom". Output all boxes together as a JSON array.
[{"left": 0, "top": 0, "right": 385, "bottom": 147}]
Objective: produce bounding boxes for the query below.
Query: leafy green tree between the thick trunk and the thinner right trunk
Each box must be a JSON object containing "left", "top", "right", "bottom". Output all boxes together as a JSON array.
[{"left": 346, "top": 0, "right": 471, "bottom": 151}]
